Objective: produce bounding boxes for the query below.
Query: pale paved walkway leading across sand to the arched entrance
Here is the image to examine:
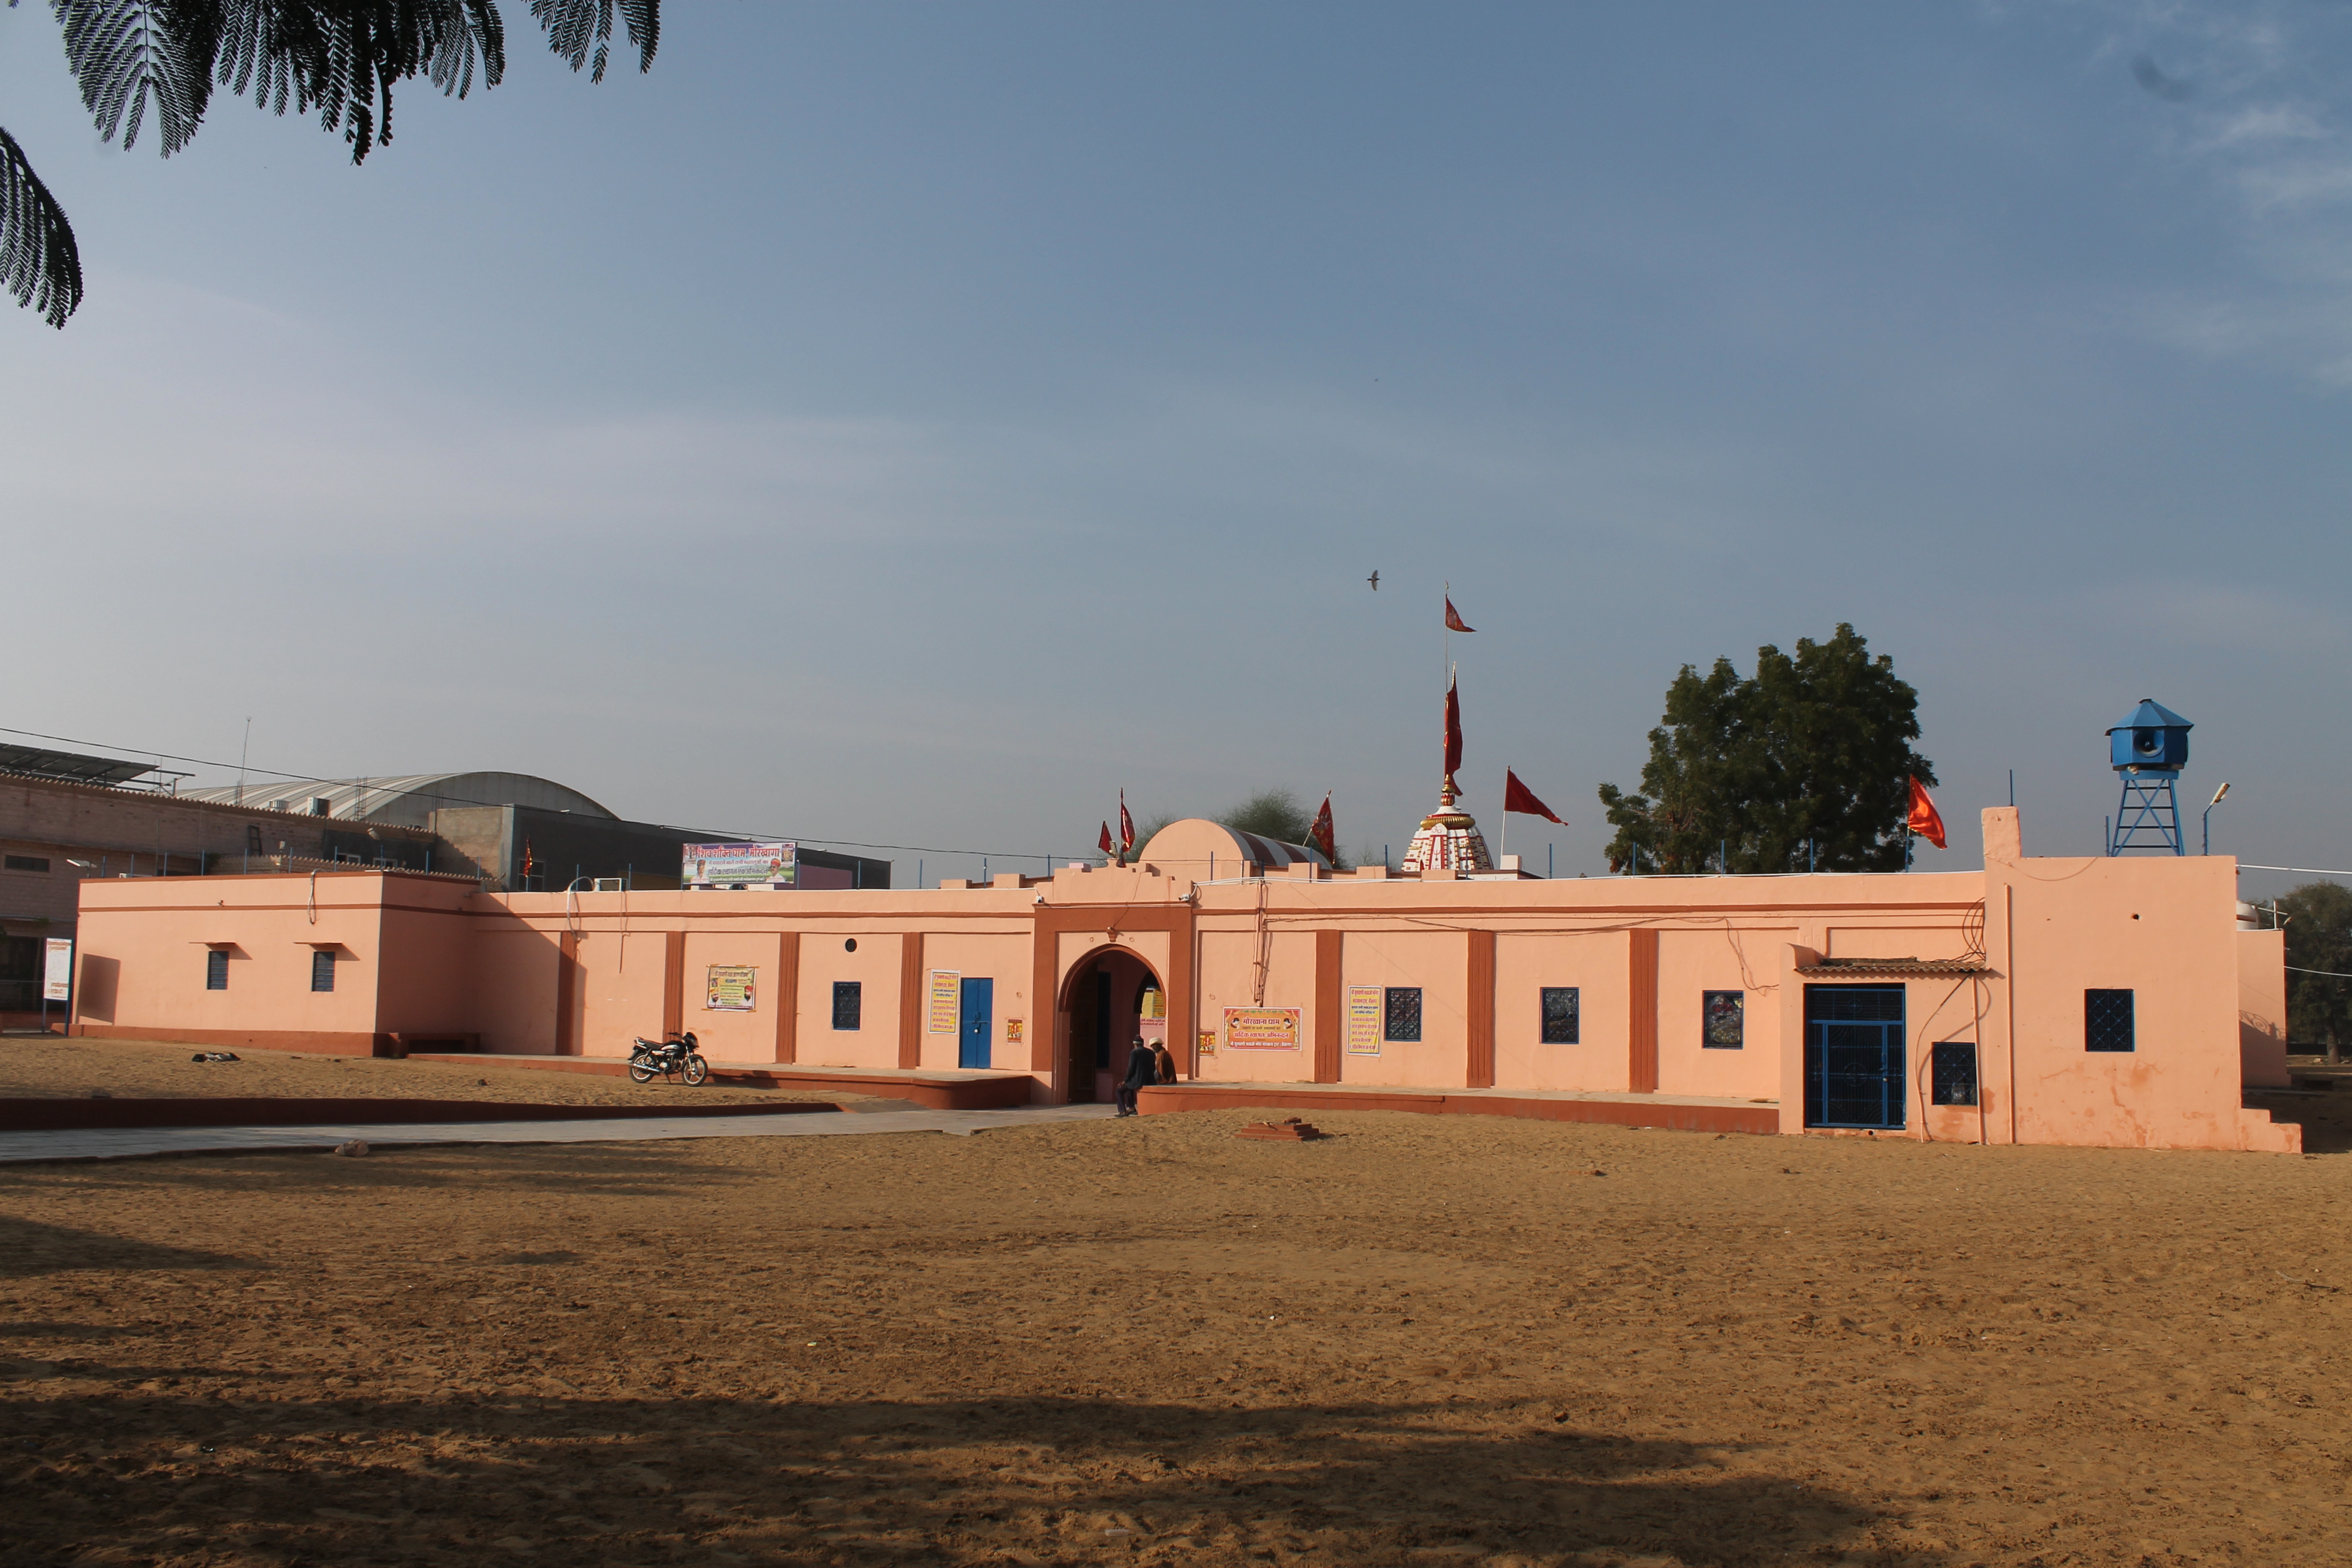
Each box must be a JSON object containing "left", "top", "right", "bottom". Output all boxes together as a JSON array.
[{"left": 0, "top": 1105, "right": 1113, "bottom": 1166}]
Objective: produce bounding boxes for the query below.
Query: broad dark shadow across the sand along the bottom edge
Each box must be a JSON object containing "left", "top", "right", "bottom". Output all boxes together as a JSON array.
[{"left": 0, "top": 1389, "right": 1945, "bottom": 1568}]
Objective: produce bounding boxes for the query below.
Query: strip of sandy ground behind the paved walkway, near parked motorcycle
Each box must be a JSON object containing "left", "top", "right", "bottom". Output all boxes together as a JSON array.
[{"left": 0, "top": 1035, "right": 868, "bottom": 1105}]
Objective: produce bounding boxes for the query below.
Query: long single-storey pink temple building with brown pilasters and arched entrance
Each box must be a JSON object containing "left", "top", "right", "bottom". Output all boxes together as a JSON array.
[{"left": 70, "top": 809, "right": 2300, "bottom": 1152}]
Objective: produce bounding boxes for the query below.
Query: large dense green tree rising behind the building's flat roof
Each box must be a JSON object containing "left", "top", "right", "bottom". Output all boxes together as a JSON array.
[{"left": 1599, "top": 623, "right": 1936, "bottom": 872}]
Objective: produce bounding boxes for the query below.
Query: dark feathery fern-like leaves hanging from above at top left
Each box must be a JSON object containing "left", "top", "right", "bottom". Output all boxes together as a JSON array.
[{"left": 0, "top": 0, "right": 661, "bottom": 327}]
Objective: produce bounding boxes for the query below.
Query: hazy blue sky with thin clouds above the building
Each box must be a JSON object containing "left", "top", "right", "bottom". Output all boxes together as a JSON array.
[{"left": 0, "top": 0, "right": 2352, "bottom": 891}]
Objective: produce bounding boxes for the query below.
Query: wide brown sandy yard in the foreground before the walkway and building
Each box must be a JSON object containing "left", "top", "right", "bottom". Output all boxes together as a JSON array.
[{"left": 0, "top": 1112, "right": 2352, "bottom": 1568}]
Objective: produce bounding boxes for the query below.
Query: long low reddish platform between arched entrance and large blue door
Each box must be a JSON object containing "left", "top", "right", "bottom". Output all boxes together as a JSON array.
[{"left": 1136, "top": 1081, "right": 1781, "bottom": 1133}]
